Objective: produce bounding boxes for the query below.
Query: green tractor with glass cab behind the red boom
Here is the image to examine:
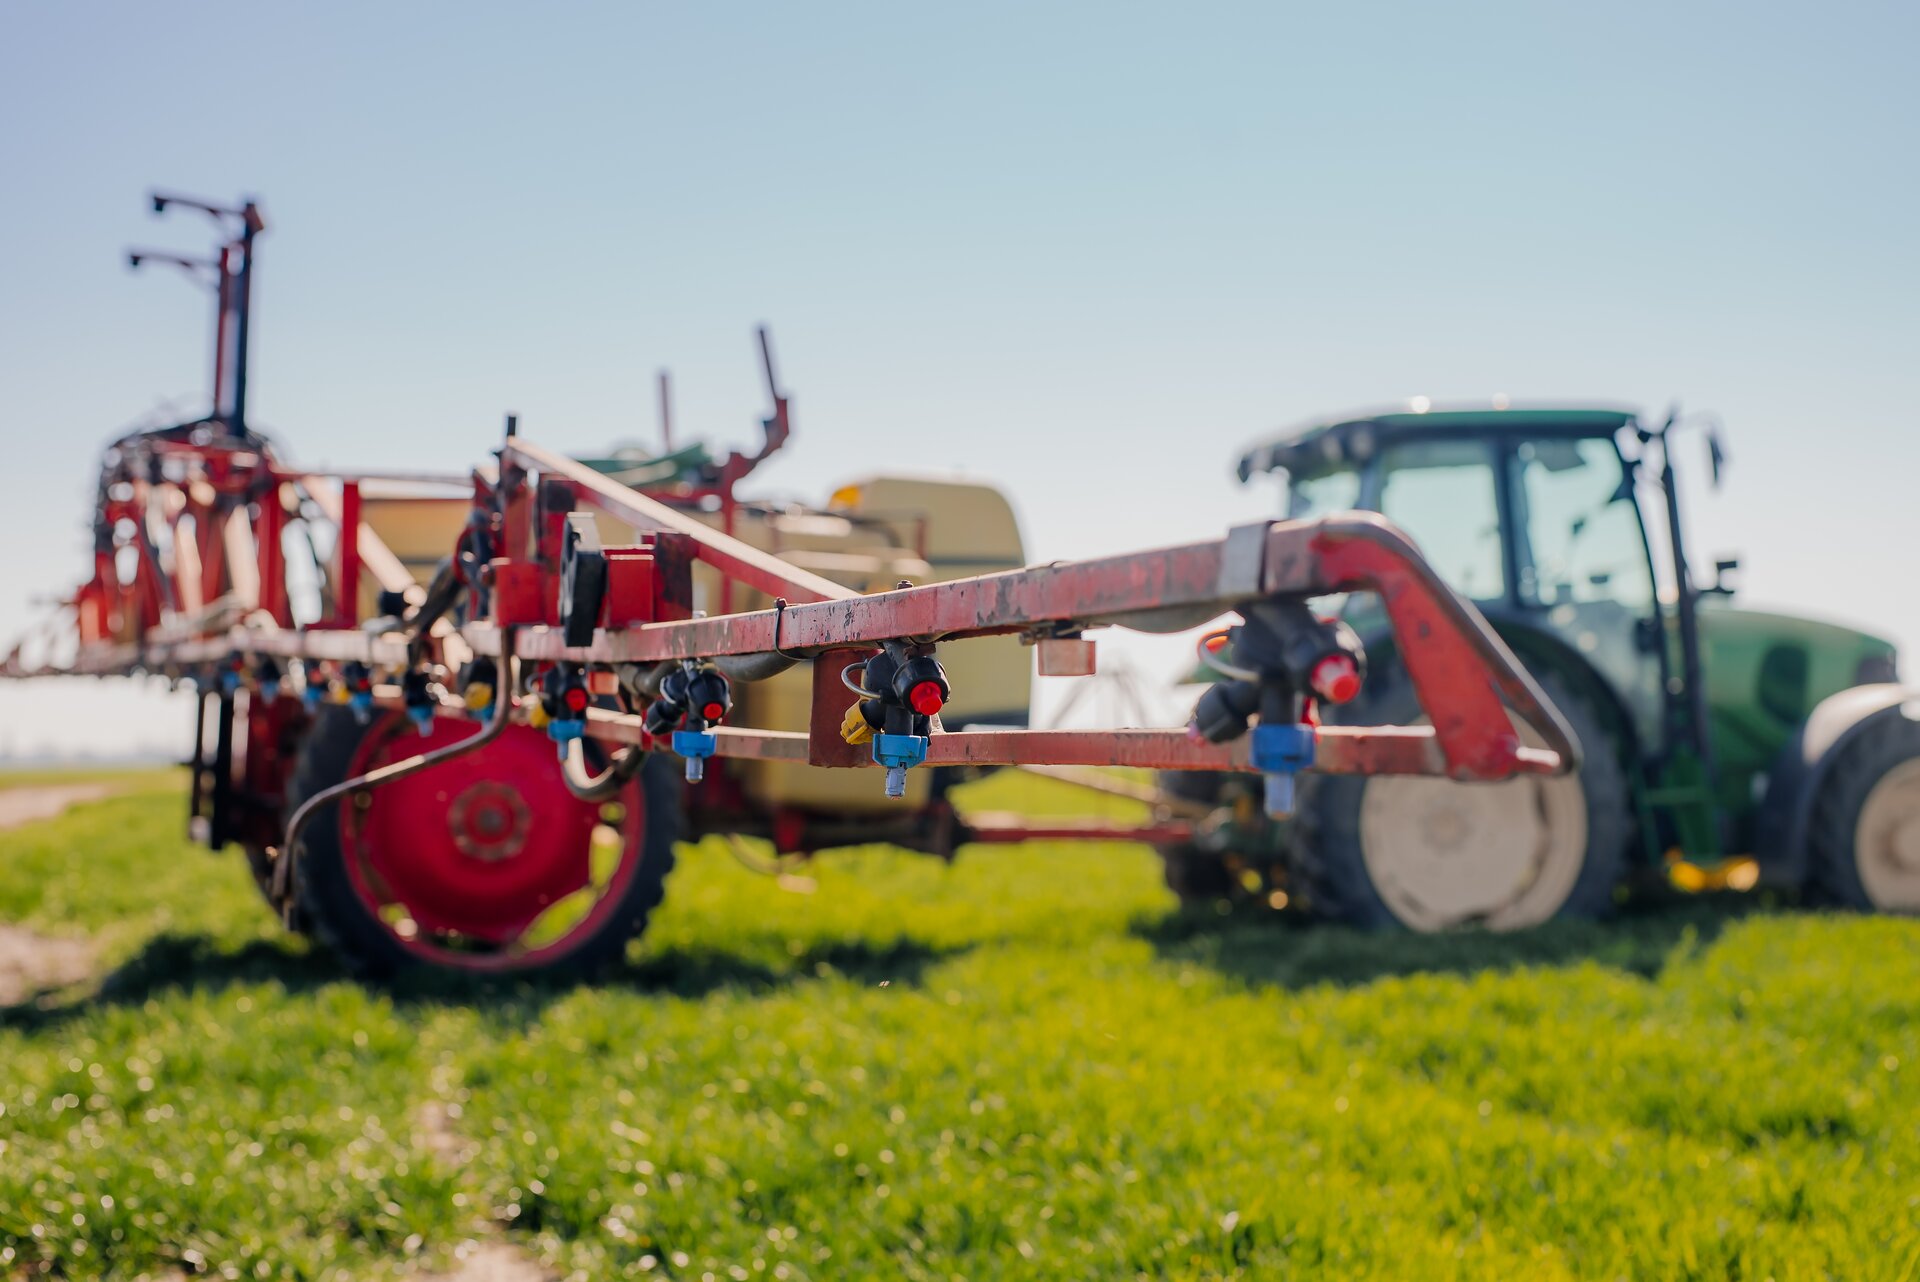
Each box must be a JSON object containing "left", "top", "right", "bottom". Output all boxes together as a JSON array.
[{"left": 1162, "top": 401, "right": 1920, "bottom": 931}]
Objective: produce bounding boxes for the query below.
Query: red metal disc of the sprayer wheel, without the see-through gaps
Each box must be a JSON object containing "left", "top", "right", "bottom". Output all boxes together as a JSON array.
[{"left": 340, "top": 716, "right": 645, "bottom": 944}]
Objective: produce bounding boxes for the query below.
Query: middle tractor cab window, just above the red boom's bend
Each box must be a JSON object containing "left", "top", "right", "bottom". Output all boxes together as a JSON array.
[{"left": 1379, "top": 439, "right": 1507, "bottom": 601}]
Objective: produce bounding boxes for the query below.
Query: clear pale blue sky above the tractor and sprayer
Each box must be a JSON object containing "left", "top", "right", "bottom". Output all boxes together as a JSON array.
[{"left": 0, "top": 4, "right": 1920, "bottom": 752}]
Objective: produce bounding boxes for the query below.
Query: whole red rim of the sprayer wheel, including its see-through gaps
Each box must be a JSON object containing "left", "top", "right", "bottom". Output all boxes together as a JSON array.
[{"left": 340, "top": 714, "right": 647, "bottom": 971}]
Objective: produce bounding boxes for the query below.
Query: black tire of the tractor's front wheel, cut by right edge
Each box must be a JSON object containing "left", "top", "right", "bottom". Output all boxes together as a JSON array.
[{"left": 1807, "top": 708, "right": 1920, "bottom": 914}]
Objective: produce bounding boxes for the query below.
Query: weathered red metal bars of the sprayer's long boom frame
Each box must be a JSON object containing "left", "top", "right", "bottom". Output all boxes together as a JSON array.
[{"left": 18, "top": 436, "right": 1576, "bottom": 779}]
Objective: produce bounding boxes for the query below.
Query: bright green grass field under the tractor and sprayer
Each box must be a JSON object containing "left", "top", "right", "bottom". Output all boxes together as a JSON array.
[{"left": 0, "top": 775, "right": 1920, "bottom": 1282}]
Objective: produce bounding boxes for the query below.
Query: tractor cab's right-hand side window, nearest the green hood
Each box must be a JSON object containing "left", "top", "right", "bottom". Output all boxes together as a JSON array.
[{"left": 1511, "top": 438, "right": 1653, "bottom": 614}]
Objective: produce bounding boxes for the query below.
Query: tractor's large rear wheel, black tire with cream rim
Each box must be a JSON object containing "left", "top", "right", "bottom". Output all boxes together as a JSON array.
[{"left": 1290, "top": 668, "right": 1634, "bottom": 931}]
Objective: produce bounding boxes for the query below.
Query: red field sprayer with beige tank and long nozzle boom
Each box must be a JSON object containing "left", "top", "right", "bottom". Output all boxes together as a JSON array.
[{"left": 4, "top": 192, "right": 1576, "bottom": 973}]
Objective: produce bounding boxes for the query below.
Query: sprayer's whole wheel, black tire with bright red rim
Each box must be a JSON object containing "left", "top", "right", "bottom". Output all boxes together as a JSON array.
[{"left": 286, "top": 708, "right": 678, "bottom": 975}]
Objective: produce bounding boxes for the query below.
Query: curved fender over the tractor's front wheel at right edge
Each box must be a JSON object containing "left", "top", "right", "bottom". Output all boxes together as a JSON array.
[{"left": 1753, "top": 683, "right": 1920, "bottom": 889}]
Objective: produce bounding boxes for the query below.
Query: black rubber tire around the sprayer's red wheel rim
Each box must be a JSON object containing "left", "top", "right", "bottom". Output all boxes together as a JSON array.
[{"left": 286, "top": 706, "right": 682, "bottom": 979}]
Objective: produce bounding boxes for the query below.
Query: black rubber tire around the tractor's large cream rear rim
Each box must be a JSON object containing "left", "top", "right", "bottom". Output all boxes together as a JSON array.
[{"left": 1288, "top": 664, "right": 1636, "bottom": 931}]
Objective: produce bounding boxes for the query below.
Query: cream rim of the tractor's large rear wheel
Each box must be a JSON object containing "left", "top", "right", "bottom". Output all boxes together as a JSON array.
[{"left": 1359, "top": 725, "right": 1588, "bottom": 931}]
